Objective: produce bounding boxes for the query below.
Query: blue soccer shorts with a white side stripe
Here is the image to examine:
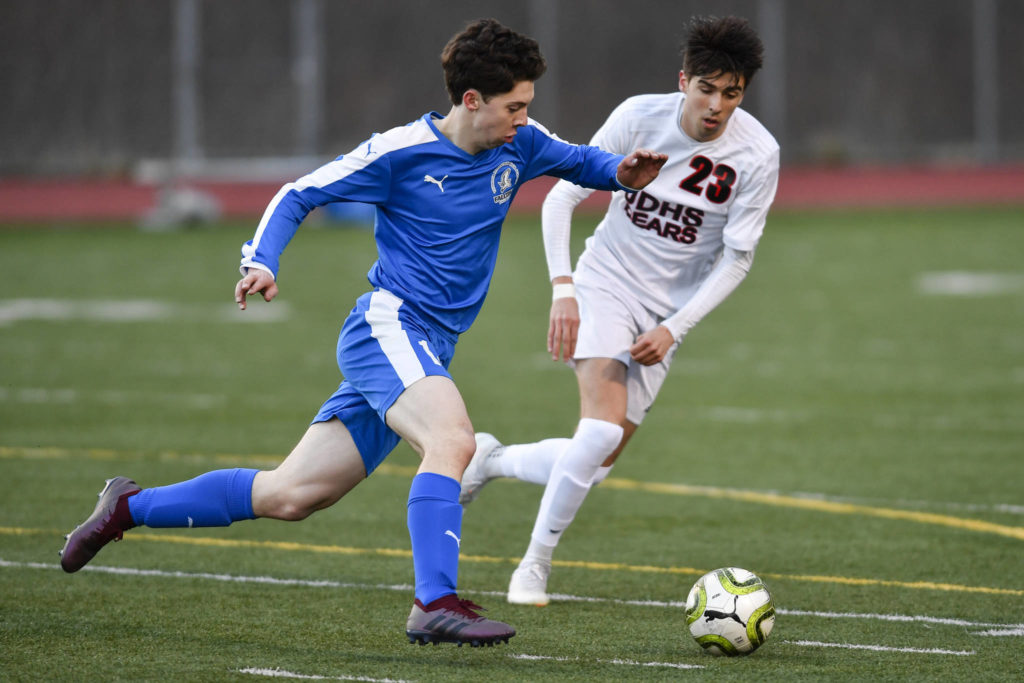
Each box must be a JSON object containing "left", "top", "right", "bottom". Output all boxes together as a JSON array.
[{"left": 313, "top": 290, "right": 457, "bottom": 476}]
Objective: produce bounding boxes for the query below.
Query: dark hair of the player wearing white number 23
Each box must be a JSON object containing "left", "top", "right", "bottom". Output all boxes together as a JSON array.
[{"left": 682, "top": 16, "right": 765, "bottom": 85}]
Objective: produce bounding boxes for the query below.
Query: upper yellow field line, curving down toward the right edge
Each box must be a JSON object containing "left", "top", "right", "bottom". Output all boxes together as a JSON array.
[{"left": 0, "top": 445, "right": 1024, "bottom": 541}]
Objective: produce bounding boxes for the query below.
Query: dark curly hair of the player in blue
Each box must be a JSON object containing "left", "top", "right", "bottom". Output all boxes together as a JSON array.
[{"left": 441, "top": 19, "right": 548, "bottom": 104}]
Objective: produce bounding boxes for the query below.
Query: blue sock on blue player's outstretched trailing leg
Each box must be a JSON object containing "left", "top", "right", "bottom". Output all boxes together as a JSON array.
[{"left": 128, "top": 468, "right": 258, "bottom": 527}]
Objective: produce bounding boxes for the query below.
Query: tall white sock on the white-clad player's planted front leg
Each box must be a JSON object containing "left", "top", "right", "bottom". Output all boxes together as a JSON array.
[{"left": 530, "top": 418, "right": 623, "bottom": 549}]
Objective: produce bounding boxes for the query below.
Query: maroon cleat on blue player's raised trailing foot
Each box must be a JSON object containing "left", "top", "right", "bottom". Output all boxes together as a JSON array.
[{"left": 60, "top": 477, "right": 142, "bottom": 573}]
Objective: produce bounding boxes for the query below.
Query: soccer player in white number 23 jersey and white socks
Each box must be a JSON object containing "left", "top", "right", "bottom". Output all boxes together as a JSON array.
[{"left": 461, "top": 17, "right": 778, "bottom": 605}]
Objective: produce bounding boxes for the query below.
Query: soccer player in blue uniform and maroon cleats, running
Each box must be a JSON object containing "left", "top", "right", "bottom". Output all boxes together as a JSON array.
[{"left": 60, "top": 15, "right": 667, "bottom": 646}]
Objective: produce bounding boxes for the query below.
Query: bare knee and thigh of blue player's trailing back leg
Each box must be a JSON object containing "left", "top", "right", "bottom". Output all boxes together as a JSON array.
[{"left": 252, "top": 420, "right": 367, "bottom": 518}]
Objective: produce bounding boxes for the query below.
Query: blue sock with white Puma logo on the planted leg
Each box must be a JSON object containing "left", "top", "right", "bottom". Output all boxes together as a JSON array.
[{"left": 405, "top": 472, "right": 462, "bottom": 605}]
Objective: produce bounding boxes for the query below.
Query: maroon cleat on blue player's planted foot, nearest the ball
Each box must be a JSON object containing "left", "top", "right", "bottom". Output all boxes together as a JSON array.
[{"left": 406, "top": 593, "right": 515, "bottom": 647}]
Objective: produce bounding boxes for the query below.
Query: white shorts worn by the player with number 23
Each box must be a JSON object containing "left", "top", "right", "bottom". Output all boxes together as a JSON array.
[{"left": 572, "top": 270, "right": 679, "bottom": 425}]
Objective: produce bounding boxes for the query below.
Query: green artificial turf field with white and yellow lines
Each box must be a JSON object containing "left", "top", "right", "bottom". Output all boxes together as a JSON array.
[{"left": 0, "top": 208, "right": 1024, "bottom": 681}]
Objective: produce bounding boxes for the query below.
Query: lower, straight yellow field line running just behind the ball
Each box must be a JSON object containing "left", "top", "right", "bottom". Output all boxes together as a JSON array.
[{"left": 0, "top": 526, "right": 1024, "bottom": 597}]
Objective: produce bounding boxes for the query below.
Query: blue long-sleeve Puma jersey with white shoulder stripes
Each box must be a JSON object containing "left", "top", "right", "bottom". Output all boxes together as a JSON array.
[{"left": 242, "top": 112, "right": 625, "bottom": 335}]
